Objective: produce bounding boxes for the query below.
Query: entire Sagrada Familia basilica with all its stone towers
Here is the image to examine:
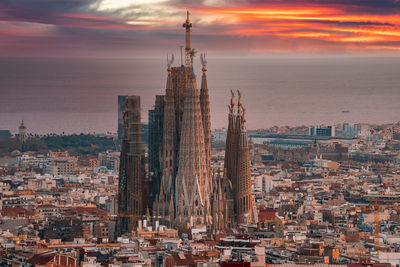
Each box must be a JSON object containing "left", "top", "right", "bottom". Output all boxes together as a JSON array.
[{"left": 118, "top": 12, "right": 256, "bottom": 236}]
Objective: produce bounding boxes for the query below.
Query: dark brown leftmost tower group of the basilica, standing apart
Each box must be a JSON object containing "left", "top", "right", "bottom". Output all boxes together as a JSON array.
[{"left": 116, "top": 96, "right": 145, "bottom": 234}]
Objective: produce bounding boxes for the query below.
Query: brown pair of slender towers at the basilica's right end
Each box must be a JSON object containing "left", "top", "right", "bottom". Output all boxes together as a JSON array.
[{"left": 224, "top": 91, "right": 256, "bottom": 226}]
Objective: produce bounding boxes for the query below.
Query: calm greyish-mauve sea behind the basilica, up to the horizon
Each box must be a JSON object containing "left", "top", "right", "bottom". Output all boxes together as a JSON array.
[{"left": 0, "top": 56, "right": 400, "bottom": 133}]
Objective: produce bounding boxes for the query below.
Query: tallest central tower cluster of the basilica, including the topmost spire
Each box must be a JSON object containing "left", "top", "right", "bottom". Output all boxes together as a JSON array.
[{"left": 149, "top": 12, "right": 212, "bottom": 231}]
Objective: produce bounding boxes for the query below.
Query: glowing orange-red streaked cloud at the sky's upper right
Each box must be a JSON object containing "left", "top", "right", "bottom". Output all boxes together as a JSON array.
[{"left": 197, "top": 6, "right": 400, "bottom": 50}]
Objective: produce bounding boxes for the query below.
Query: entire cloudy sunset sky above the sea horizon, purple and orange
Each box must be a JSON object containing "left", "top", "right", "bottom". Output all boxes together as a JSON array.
[{"left": 0, "top": 0, "right": 400, "bottom": 57}]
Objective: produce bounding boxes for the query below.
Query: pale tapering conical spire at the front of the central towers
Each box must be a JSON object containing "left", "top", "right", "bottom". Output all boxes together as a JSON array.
[{"left": 175, "top": 57, "right": 210, "bottom": 231}]
